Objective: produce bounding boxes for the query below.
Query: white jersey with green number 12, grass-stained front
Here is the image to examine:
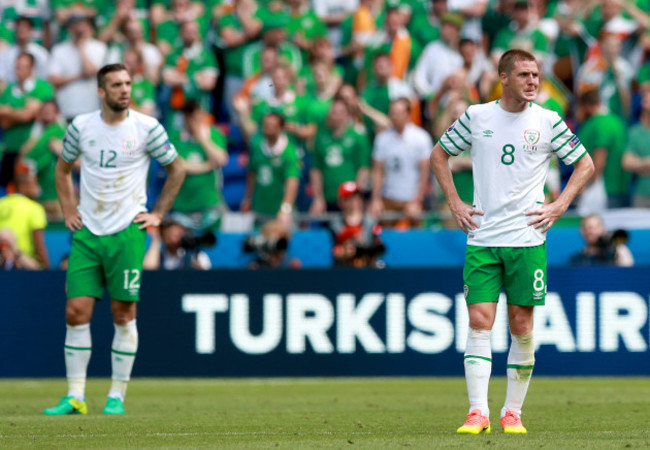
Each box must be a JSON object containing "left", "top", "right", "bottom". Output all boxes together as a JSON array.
[{"left": 61, "top": 110, "right": 177, "bottom": 236}]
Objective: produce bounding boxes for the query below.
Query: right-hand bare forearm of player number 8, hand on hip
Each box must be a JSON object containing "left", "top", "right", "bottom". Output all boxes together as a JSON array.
[{"left": 526, "top": 152, "right": 594, "bottom": 231}]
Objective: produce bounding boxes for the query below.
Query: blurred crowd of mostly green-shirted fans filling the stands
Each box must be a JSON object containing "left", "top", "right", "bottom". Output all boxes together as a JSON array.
[{"left": 0, "top": 0, "right": 650, "bottom": 267}]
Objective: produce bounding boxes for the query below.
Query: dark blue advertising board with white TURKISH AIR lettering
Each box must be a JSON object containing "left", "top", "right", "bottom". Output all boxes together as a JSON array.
[{"left": 0, "top": 267, "right": 650, "bottom": 377}]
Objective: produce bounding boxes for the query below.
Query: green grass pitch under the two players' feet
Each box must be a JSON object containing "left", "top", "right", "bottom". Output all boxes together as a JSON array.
[{"left": 0, "top": 377, "right": 650, "bottom": 449}]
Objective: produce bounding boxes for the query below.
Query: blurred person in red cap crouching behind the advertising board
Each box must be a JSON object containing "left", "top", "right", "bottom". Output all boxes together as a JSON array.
[{"left": 330, "top": 181, "right": 386, "bottom": 267}]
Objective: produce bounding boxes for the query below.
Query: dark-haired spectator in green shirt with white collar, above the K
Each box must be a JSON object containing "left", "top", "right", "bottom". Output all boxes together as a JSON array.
[{"left": 240, "top": 112, "right": 301, "bottom": 225}]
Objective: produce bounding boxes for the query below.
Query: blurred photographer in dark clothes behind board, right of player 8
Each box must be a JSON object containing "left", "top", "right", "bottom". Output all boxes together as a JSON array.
[{"left": 569, "top": 215, "right": 634, "bottom": 267}]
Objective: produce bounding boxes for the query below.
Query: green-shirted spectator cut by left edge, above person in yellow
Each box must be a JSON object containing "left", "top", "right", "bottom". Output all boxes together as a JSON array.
[{"left": 0, "top": 53, "right": 54, "bottom": 187}]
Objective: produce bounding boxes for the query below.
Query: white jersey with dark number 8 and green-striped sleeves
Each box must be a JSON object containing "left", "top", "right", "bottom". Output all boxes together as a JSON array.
[{"left": 439, "top": 100, "right": 587, "bottom": 247}]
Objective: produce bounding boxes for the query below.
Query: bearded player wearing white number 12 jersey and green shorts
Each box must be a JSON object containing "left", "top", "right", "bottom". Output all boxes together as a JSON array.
[{"left": 44, "top": 64, "right": 185, "bottom": 415}]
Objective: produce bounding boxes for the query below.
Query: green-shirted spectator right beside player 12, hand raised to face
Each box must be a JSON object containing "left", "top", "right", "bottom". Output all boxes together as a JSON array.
[{"left": 169, "top": 100, "right": 228, "bottom": 233}]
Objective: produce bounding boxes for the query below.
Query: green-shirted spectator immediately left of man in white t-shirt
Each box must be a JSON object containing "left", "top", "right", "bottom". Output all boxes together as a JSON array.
[{"left": 309, "top": 99, "right": 370, "bottom": 214}]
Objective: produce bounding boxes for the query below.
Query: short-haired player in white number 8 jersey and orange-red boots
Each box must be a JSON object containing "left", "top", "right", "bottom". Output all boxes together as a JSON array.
[{"left": 430, "top": 50, "right": 594, "bottom": 434}]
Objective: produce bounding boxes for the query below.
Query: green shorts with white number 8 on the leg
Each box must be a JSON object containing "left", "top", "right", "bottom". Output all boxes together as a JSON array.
[{"left": 463, "top": 243, "right": 546, "bottom": 306}]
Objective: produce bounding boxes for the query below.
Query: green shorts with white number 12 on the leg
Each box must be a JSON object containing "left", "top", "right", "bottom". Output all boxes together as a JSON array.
[{"left": 66, "top": 223, "right": 146, "bottom": 302}]
